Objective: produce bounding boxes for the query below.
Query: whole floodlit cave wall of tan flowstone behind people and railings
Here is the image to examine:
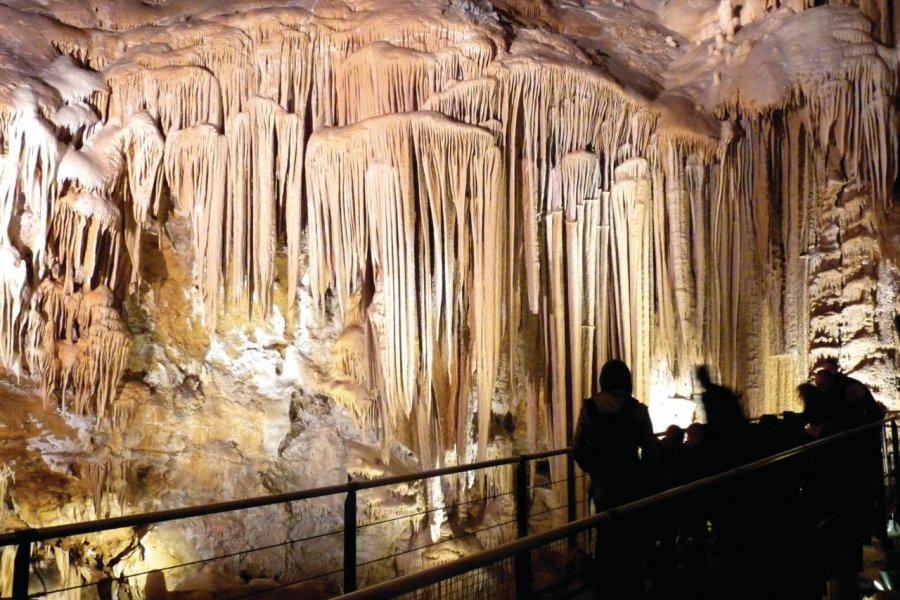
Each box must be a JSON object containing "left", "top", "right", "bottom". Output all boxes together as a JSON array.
[{"left": 0, "top": 0, "right": 900, "bottom": 597}]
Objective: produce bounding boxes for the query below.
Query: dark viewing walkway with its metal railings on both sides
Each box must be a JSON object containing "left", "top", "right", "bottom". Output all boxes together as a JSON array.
[{"left": 0, "top": 416, "right": 900, "bottom": 600}]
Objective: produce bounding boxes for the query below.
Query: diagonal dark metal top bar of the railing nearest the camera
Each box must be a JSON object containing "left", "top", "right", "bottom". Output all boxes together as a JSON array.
[{"left": 338, "top": 416, "right": 898, "bottom": 600}]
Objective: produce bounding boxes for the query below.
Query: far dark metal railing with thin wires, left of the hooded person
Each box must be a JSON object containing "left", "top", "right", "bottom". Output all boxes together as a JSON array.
[{"left": 0, "top": 448, "right": 585, "bottom": 600}]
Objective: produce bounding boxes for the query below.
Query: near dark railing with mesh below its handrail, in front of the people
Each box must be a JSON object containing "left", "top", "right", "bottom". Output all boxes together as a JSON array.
[{"left": 340, "top": 418, "right": 900, "bottom": 600}]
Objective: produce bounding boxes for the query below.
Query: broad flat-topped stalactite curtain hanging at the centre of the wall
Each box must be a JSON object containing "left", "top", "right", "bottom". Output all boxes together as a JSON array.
[{"left": 306, "top": 115, "right": 506, "bottom": 462}]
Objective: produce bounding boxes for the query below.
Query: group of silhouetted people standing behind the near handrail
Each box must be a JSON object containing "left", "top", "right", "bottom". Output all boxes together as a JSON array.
[{"left": 573, "top": 360, "right": 885, "bottom": 598}]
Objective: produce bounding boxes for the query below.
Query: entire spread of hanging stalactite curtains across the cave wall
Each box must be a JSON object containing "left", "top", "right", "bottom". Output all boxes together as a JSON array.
[{"left": 0, "top": 1, "right": 898, "bottom": 524}]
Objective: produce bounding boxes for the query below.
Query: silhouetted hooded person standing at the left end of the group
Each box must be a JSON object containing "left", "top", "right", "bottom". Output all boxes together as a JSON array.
[{"left": 574, "top": 360, "right": 659, "bottom": 598}]
